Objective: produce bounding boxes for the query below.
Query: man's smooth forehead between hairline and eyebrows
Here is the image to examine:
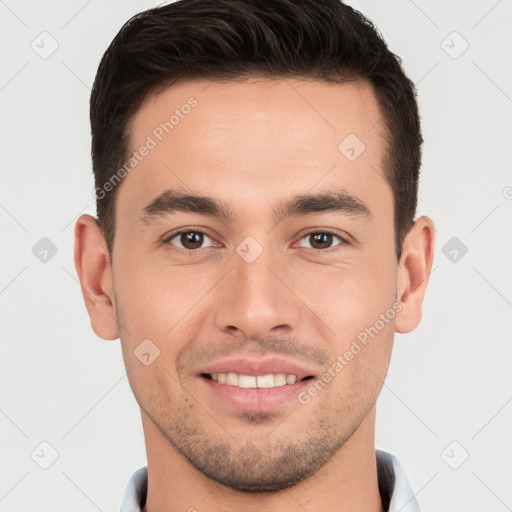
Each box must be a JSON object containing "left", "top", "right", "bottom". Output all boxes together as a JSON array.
[{"left": 118, "top": 79, "right": 391, "bottom": 224}]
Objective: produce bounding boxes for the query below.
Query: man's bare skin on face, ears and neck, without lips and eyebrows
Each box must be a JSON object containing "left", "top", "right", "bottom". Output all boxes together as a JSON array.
[{"left": 75, "top": 79, "right": 434, "bottom": 512}]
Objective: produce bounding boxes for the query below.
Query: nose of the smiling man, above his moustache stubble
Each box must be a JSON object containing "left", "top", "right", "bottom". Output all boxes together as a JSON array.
[{"left": 215, "top": 239, "right": 302, "bottom": 340}]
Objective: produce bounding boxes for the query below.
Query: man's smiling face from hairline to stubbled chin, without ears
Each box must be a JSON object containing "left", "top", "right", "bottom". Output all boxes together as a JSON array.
[{"left": 98, "top": 79, "right": 400, "bottom": 491}]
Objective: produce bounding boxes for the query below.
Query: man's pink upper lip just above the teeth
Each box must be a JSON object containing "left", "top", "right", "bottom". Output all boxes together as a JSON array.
[{"left": 200, "top": 357, "right": 314, "bottom": 379}]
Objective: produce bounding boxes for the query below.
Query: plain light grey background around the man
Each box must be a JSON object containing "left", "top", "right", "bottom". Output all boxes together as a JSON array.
[{"left": 0, "top": 0, "right": 512, "bottom": 512}]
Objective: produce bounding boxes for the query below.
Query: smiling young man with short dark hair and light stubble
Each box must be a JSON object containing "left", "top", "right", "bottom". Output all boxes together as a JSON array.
[{"left": 75, "top": 0, "right": 434, "bottom": 512}]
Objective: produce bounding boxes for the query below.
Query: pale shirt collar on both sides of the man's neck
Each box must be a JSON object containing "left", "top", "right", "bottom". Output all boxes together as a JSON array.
[{"left": 119, "top": 450, "right": 420, "bottom": 512}]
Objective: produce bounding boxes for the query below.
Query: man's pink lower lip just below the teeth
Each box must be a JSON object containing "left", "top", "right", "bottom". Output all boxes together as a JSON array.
[{"left": 200, "top": 377, "right": 314, "bottom": 412}]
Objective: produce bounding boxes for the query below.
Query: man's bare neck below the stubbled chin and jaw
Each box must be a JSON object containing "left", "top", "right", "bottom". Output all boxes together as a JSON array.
[{"left": 142, "top": 407, "right": 384, "bottom": 512}]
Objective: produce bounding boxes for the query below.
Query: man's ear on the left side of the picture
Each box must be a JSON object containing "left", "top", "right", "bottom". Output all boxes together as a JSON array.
[{"left": 75, "top": 214, "right": 119, "bottom": 340}]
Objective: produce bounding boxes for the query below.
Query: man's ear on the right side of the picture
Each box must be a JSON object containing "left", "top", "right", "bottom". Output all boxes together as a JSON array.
[{"left": 395, "top": 217, "right": 435, "bottom": 333}]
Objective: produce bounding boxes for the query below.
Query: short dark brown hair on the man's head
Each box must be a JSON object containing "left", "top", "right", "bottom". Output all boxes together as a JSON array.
[{"left": 90, "top": 0, "right": 423, "bottom": 260}]
